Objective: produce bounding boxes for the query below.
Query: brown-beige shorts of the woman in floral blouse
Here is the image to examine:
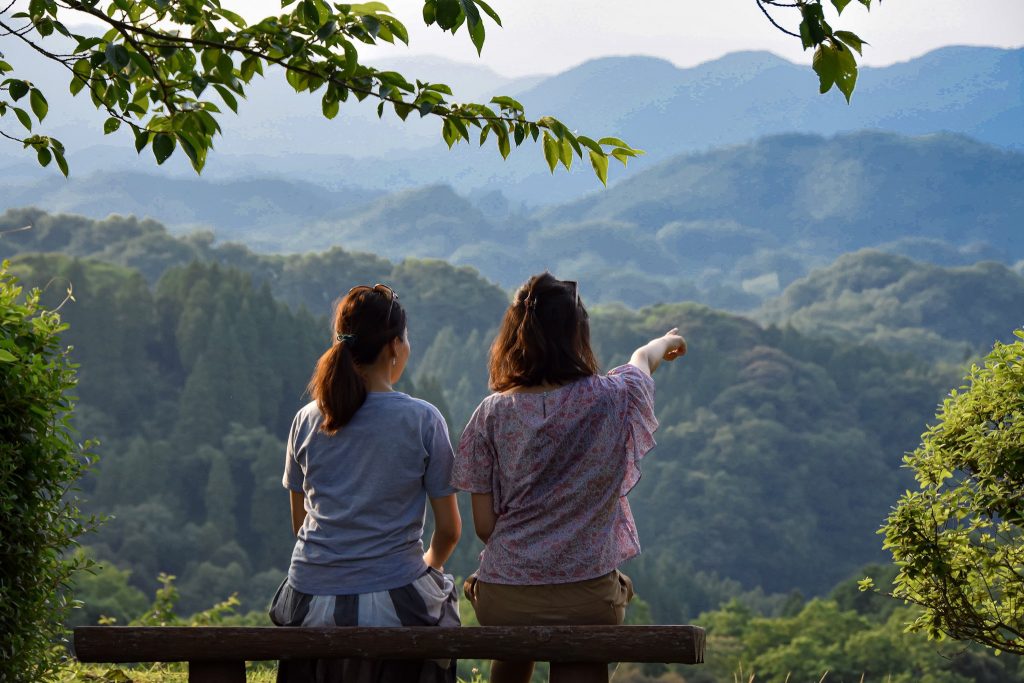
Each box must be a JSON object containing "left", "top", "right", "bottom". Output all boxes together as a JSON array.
[{"left": 463, "top": 569, "right": 633, "bottom": 626}]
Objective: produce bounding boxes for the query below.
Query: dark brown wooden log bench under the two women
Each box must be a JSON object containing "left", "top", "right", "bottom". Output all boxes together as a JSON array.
[{"left": 75, "top": 626, "right": 705, "bottom": 683}]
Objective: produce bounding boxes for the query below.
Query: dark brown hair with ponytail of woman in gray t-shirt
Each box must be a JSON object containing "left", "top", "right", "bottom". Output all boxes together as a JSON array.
[{"left": 309, "top": 287, "right": 406, "bottom": 434}]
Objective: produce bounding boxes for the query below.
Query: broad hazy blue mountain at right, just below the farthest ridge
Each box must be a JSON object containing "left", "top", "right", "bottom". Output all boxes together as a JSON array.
[{"left": 538, "top": 132, "right": 1024, "bottom": 252}]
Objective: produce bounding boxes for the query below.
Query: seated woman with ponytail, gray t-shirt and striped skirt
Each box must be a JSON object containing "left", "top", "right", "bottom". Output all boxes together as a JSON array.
[{"left": 270, "top": 285, "right": 462, "bottom": 683}]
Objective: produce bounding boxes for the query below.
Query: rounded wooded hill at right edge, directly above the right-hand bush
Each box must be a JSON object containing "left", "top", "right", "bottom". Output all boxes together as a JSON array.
[{"left": 759, "top": 250, "right": 1024, "bottom": 361}]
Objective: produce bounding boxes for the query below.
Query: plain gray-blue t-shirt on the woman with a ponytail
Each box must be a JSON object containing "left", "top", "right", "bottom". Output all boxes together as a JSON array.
[{"left": 283, "top": 391, "right": 456, "bottom": 595}]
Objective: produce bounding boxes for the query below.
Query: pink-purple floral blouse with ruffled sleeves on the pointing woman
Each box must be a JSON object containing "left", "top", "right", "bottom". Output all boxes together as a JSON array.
[{"left": 452, "top": 366, "right": 657, "bottom": 585}]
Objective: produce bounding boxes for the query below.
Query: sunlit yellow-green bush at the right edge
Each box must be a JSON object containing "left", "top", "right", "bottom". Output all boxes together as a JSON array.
[{"left": 864, "top": 330, "right": 1024, "bottom": 654}]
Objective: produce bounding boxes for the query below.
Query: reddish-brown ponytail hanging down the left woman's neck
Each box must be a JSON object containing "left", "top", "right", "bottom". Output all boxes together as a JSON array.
[{"left": 309, "top": 341, "right": 367, "bottom": 434}]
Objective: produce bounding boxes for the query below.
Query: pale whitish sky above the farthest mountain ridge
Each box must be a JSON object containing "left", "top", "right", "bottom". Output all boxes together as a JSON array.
[{"left": 44, "top": 0, "right": 1024, "bottom": 77}]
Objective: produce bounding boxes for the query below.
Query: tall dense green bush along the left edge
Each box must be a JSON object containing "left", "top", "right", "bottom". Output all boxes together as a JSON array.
[{"left": 0, "top": 262, "right": 95, "bottom": 681}]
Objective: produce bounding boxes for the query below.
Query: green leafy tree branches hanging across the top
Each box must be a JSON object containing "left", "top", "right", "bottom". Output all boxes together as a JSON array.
[{"left": 0, "top": 0, "right": 869, "bottom": 183}]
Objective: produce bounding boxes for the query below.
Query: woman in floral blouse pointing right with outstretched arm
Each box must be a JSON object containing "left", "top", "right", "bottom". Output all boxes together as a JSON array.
[{"left": 453, "top": 272, "right": 686, "bottom": 683}]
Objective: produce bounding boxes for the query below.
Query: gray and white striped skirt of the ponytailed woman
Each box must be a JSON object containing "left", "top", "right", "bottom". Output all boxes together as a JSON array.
[{"left": 270, "top": 568, "right": 462, "bottom": 683}]
